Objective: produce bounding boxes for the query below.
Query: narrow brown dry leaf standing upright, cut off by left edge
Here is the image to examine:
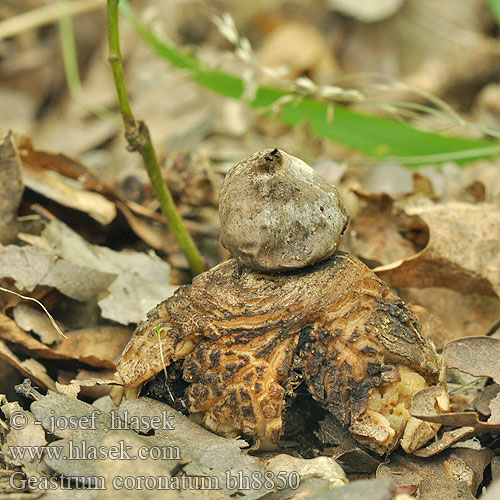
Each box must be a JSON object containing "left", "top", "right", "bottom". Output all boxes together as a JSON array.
[{"left": 0, "top": 132, "right": 24, "bottom": 245}]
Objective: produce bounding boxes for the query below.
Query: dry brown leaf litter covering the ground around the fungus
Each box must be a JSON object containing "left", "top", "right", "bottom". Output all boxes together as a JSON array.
[{"left": 0, "top": 0, "right": 500, "bottom": 500}]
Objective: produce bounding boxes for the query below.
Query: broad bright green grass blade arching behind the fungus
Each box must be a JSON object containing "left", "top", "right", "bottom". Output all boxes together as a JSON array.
[{"left": 120, "top": 0, "right": 500, "bottom": 165}]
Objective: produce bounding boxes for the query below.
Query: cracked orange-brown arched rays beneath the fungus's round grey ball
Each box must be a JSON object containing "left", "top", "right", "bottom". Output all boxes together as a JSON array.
[{"left": 113, "top": 252, "right": 440, "bottom": 453}]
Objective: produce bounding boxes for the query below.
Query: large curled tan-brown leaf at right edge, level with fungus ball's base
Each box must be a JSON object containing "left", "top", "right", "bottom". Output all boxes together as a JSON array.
[{"left": 374, "top": 202, "right": 500, "bottom": 296}]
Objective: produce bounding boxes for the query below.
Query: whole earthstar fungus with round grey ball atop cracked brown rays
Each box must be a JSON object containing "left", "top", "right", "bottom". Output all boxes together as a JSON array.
[{"left": 112, "top": 149, "right": 440, "bottom": 453}]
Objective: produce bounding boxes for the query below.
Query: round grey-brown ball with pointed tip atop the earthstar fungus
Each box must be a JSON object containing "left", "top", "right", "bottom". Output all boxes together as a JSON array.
[{"left": 219, "top": 149, "right": 349, "bottom": 272}]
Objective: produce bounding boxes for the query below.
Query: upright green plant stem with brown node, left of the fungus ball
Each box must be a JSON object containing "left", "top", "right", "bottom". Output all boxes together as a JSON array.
[{"left": 108, "top": 0, "right": 206, "bottom": 275}]
